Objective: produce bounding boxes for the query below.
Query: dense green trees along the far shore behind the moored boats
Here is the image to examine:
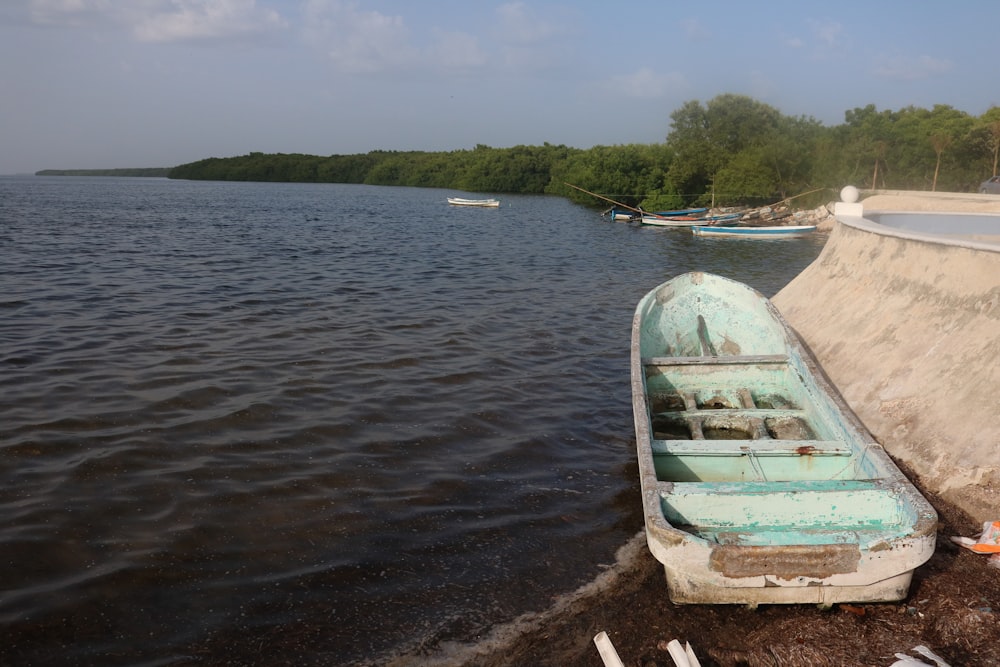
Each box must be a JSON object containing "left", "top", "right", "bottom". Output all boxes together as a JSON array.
[{"left": 169, "top": 94, "right": 1000, "bottom": 210}]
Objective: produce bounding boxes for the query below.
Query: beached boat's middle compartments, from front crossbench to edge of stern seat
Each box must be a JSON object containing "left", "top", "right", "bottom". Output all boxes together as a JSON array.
[{"left": 643, "top": 355, "right": 864, "bottom": 482}]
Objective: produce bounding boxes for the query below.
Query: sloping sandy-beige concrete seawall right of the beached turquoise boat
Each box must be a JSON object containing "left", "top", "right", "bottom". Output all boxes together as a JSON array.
[{"left": 774, "top": 193, "right": 1000, "bottom": 522}]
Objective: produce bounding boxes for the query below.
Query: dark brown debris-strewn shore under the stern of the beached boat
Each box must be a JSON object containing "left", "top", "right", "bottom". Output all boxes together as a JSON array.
[{"left": 436, "top": 472, "right": 1000, "bottom": 667}]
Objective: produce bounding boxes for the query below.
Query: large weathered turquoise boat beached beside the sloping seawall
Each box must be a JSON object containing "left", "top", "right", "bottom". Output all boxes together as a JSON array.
[{"left": 631, "top": 273, "right": 937, "bottom": 606}]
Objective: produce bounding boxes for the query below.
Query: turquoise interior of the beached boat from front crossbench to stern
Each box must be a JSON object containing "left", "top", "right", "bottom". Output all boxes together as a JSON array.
[{"left": 642, "top": 354, "right": 917, "bottom": 546}]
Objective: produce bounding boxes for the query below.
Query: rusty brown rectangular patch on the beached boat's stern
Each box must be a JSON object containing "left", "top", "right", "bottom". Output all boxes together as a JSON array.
[{"left": 709, "top": 544, "right": 861, "bottom": 579}]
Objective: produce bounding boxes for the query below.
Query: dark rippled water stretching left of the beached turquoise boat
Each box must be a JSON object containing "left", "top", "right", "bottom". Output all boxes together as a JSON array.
[{"left": 0, "top": 177, "right": 825, "bottom": 665}]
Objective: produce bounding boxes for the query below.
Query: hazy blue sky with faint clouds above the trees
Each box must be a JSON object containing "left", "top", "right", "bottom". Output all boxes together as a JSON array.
[{"left": 0, "top": 0, "right": 1000, "bottom": 174}]
